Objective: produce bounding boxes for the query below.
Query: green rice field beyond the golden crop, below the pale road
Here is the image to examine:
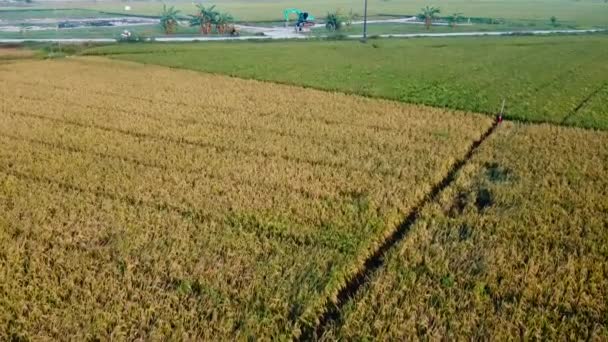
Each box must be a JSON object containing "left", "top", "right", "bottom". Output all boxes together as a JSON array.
[{"left": 86, "top": 35, "right": 608, "bottom": 130}]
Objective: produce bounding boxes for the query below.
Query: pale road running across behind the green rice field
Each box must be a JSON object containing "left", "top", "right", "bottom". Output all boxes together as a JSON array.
[{"left": 0, "top": 29, "right": 608, "bottom": 44}]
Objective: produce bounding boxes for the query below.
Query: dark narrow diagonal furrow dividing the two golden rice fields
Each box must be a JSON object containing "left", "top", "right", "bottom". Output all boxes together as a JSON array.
[{"left": 298, "top": 120, "right": 499, "bottom": 341}]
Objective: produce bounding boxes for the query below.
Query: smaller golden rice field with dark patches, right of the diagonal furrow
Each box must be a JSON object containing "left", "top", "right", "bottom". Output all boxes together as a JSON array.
[{"left": 324, "top": 123, "right": 608, "bottom": 341}]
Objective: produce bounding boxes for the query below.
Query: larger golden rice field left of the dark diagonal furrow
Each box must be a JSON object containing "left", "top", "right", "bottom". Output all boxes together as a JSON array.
[{"left": 0, "top": 58, "right": 494, "bottom": 340}]
